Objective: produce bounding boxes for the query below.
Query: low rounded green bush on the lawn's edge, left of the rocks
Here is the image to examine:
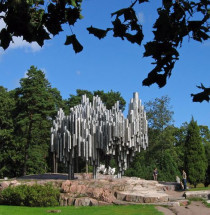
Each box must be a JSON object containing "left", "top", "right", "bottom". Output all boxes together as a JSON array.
[{"left": 0, "top": 184, "right": 60, "bottom": 207}]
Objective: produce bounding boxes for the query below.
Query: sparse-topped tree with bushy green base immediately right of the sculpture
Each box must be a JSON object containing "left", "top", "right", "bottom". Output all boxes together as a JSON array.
[{"left": 126, "top": 96, "right": 180, "bottom": 181}]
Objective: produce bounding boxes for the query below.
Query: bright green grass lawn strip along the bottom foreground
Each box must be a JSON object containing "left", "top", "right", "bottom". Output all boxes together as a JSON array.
[{"left": 0, "top": 205, "right": 163, "bottom": 215}]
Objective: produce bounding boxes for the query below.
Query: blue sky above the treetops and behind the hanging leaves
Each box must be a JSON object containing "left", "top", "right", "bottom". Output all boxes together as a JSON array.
[{"left": 0, "top": 0, "right": 210, "bottom": 128}]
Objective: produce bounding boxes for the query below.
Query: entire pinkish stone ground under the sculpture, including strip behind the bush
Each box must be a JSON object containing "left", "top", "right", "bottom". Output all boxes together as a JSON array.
[{"left": 0, "top": 174, "right": 183, "bottom": 206}]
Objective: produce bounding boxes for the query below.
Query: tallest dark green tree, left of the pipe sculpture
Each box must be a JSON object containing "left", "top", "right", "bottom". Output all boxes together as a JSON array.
[{"left": 15, "top": 66, "right": 58, "bottom": 175}]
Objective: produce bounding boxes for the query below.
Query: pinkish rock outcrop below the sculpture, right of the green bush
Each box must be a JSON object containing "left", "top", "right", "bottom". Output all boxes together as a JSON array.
[{"left": 57, "top": 177, "right": 174, "bottom": 206}]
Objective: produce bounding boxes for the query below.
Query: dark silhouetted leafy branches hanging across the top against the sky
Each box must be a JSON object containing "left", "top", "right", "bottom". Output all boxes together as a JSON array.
[{"left": 0, "top": 0, "right": 210, "bottom": 102}]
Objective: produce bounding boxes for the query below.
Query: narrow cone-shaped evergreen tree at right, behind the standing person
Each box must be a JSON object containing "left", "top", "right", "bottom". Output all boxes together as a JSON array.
[{"left": 184, "top": 118, "right": 207, "bottom": 187}]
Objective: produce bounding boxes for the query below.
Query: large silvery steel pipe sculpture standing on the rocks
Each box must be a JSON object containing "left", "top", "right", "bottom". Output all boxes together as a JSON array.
[{"left": 51, "top": 93, "right": 148, "bottom": 179}]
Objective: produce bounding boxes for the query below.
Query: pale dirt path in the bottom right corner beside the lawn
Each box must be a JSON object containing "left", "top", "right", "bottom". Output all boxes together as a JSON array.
[{"left": 156, "top": 202, "right": 210, "bottom": 215}]
